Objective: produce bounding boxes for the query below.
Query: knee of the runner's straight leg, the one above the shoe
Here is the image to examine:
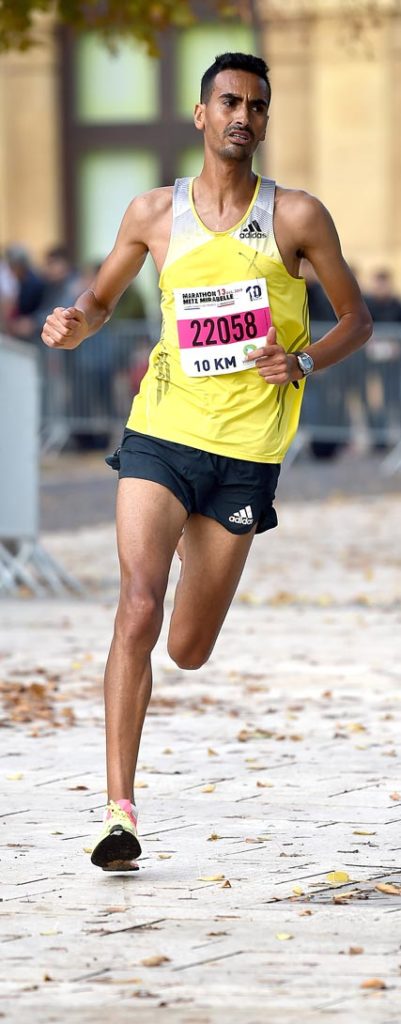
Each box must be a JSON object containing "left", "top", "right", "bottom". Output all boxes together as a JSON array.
[{"left": 115, "top": 584, "right": 163, "bottom": 646}]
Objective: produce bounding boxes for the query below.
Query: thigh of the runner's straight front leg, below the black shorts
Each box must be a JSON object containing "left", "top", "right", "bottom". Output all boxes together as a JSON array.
[{"left": 117, "top": 477, "right": 187, "bottom": 596}]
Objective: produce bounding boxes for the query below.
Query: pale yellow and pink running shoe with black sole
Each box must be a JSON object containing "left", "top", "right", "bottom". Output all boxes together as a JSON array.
[{"left": 90, "top": 800, "right": 142, "bottom": 871}]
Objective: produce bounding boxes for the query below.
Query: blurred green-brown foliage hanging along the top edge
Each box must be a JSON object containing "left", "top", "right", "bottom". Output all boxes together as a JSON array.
[{"left": 0, "top": 0, "right": 248, "bottom": 55}]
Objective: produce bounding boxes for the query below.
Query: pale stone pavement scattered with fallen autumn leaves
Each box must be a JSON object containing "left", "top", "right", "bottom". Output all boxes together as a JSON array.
[{"left": 0, "top": 497, "right": 401, "bottom": 1024}]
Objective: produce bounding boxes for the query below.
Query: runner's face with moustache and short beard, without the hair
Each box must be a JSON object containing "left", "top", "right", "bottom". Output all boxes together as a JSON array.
[{"left": 194, "top": 70, "right": 268, "bottom": 163}]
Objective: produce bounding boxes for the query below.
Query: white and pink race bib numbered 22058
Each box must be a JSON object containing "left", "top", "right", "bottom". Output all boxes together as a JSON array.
[{"left": 174, "top": 278, "right": 271, "bottom": 377}]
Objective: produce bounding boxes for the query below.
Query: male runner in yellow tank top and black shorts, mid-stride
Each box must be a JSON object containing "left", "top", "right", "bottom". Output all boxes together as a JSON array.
[{"left": 42, "top": 46, "right": 371, "bottom": 870}]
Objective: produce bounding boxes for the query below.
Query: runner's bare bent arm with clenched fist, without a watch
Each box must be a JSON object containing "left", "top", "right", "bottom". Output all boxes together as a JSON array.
[{"left": 42, "top": 195, "right": 155, "bottom": 348}]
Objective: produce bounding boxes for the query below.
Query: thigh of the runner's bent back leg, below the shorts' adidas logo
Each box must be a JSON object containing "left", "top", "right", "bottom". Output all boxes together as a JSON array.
[{"left": 169, "top": 514, "right": 256, "bottom": 656}]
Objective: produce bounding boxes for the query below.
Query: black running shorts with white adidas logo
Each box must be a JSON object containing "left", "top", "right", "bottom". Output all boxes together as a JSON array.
[{"left": 105, "top": 429, "right": 280, "bottom": 534}]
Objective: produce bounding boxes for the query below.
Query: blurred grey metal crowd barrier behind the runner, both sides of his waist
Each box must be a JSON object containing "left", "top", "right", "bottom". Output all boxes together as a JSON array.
[{"left": 40, "top": 319, "right": 401, "bottom": 468}]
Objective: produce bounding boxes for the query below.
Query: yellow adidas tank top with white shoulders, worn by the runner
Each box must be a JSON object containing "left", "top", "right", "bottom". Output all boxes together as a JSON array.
[{"left": 127, "top": 177, "right": 310, "bottom": 463}]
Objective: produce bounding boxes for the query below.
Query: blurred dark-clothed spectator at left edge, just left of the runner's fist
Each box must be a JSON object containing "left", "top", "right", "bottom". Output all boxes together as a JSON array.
[{"left": 5, "top": 245, "right": 45, "bottom": 341}]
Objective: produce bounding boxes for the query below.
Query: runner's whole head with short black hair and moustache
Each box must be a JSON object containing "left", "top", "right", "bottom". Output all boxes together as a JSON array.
[{"left": 194, "top": 53, "right": 270, "bottom": 163}]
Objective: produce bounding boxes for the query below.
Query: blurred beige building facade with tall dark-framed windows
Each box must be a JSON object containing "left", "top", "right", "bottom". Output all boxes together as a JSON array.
[{"left": 0, "top": 0, "right": 401, "bottom": 311}]
